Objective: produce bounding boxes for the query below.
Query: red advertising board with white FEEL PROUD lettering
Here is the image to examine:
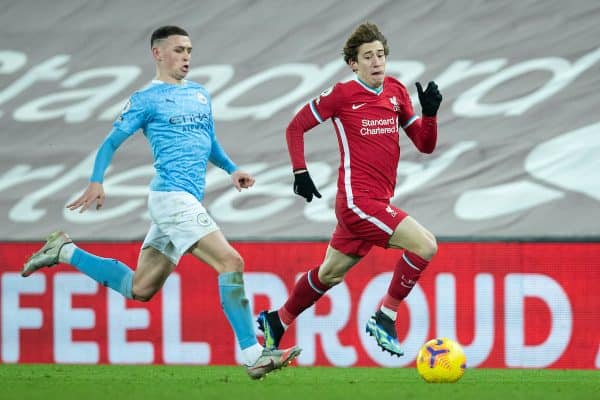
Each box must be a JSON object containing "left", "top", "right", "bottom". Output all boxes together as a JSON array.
[{"left": 0, "top": 242, "right": 600, "bottom": 369}]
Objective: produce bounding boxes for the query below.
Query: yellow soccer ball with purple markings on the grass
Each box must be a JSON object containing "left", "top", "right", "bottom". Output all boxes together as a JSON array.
[{"left": 417, "top": 338, "right": 467, "bottom": 382}]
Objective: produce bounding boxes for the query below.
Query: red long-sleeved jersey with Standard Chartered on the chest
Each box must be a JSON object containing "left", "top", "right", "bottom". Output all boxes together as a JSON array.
[{"left": 286, "top": 76, "right": 437, "bottom": 199}]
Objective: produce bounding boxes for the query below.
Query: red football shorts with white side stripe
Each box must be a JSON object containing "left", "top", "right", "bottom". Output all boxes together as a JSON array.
[{"left": 330, "top": 197, "right": 408, "bottom": 257}]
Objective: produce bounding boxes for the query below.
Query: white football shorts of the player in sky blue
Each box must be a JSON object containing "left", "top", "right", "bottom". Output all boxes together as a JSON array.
[{"left": 142, "top": 191, "right": 219, "bottom": 265}]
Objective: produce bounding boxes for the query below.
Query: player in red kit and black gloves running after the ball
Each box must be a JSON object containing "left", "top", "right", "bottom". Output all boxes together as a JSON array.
[{"left": 258, "top": 23, "right": 442, "bottom": 356}]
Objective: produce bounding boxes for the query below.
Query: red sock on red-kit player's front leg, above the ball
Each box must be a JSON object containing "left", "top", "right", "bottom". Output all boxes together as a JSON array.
[{"left": 383, "top": 251, "right": 429, "bottom": 311}]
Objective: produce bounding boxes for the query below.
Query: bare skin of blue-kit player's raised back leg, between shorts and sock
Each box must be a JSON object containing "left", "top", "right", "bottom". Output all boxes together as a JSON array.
[{"left": 133, "top": 247, "right": 175, "bottom": 295}]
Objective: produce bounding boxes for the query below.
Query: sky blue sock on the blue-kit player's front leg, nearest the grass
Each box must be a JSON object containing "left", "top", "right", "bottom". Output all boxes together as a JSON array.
[{"left": 219, "top": 272, "right": 258, "bottom": 350}]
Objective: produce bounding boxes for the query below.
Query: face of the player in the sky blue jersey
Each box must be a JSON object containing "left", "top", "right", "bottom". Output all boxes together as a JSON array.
[{"left": 152, "top": 35, "right": 192, "bottom": 83}]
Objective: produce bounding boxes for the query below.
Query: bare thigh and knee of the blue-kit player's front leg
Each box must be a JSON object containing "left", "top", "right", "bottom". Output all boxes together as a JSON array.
[{"left": 190, "top": 230, "right": 244, "bottom": 273}]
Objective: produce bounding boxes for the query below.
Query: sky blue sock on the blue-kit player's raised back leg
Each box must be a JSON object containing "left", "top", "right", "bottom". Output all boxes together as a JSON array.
[{"left": 71, "top": 248, "right": 133, "bottom": 299}]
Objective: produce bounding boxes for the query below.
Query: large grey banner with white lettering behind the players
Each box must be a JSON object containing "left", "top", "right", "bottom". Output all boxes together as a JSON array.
[{"left": 0, "top": 0, "right": 600, "bottom": 240}]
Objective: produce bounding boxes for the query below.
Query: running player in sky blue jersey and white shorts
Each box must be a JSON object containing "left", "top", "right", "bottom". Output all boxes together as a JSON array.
[{"left": 22, "top": 26, "right": 300, "bottom": 379}]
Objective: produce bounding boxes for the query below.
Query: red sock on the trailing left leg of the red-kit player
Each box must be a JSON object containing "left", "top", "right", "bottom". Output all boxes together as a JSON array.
[{"left": 278, "top": 267, "right": 329, "bottom": 326}]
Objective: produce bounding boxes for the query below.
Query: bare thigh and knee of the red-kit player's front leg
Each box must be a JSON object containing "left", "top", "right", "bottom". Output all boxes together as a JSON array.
[{"left": 389, "top": 216, "right": 437, "bottom": 260}]
